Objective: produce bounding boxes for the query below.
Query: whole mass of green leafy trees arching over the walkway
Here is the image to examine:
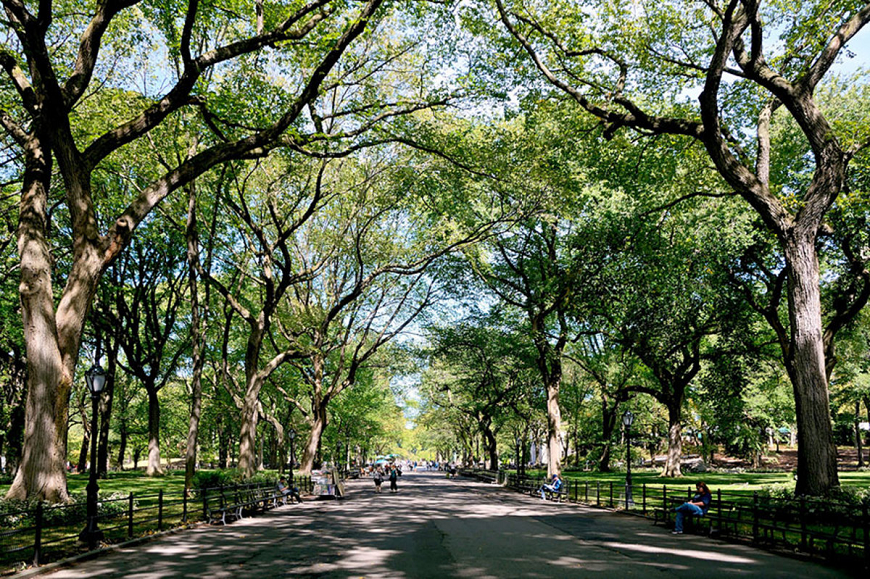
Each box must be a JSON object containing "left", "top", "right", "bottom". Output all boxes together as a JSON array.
[{"left": 0, "top": 0, "right": 870, "bottom": 501}]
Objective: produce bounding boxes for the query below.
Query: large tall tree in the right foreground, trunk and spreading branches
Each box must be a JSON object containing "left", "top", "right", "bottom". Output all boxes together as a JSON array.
[{"left": 495, "top": 0, "right": 870, "bottom": 495}]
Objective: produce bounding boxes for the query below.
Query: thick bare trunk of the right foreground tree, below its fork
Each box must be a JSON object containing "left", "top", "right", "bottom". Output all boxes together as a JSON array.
[{"left": 785, "top": 234, "right": 840, "bottom": 496}]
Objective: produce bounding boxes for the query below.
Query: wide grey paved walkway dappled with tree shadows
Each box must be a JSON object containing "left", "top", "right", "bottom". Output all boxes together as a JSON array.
[{"left": 32, "top": 473, "right": 850, "bottom": 579}]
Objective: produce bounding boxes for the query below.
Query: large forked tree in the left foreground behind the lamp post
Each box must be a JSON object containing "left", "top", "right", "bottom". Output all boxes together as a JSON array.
[{"left": 0, "top": 0, "right": 392, "bottom": 502}]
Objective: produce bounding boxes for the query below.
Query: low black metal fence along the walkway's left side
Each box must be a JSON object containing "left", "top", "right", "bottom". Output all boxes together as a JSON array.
[{"left": 0, "top": 476, "right": 313, "bottom": 573}]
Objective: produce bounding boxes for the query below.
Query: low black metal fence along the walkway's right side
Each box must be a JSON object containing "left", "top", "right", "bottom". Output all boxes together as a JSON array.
[{"left": 461, "top": 470, "right": 870, "bottom": 568}]
